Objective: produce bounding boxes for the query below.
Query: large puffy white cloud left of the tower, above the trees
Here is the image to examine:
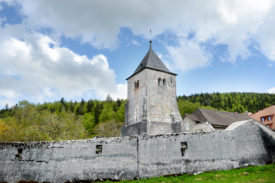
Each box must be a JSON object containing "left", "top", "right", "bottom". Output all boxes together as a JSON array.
[{"left": 0, "top": 30, "right": 126, "bottom": 107}]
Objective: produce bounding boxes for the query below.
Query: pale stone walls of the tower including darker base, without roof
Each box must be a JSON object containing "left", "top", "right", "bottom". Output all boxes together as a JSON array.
[{"left": 125, "top": 69, "right": 182, "bottom": 136}]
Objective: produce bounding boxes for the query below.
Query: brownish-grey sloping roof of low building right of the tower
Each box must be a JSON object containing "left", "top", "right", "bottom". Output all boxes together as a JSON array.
[{"left": 191, "top": 108, "right": 252, "bottom": 127}]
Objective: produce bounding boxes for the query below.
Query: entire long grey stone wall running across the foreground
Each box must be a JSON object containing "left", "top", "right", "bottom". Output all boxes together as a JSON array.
[{"left": 0, "top": 121, "right": 275, "bottom": 182}]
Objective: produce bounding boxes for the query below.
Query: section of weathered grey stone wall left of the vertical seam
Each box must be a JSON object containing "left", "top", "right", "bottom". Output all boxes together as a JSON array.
[{"left": 0, "top": 137, "right": 137, "bottom": 182}]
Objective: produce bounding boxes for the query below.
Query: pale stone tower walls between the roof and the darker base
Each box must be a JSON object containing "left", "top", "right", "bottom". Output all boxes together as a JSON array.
[{"left": 127, "top": 69, "right": 182, "bottom": 124}]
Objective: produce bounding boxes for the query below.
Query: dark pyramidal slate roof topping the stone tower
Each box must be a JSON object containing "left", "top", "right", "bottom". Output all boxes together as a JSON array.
[{"left": 127, "top": 41, "right": 176, "bottom": 80}]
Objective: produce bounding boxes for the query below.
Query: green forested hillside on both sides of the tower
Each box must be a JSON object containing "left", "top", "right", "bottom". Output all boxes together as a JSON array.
[{"left": 0, "top": 93, "right": 275, "bottom": 142}]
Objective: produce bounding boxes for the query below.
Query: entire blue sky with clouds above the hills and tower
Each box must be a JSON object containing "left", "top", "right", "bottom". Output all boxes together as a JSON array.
[{"left": 0, "top": 0, "right": 275, "bottom": 108}]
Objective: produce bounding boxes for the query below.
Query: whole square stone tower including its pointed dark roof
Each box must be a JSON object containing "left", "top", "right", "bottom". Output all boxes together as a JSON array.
[{"left": 122, "top": 41, "right": 182, "bottom": 136}]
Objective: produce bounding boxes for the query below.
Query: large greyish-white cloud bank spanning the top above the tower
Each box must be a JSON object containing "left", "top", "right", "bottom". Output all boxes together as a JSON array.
[{"left": 8, "top": 0, "right": 275, "bottom": 68}]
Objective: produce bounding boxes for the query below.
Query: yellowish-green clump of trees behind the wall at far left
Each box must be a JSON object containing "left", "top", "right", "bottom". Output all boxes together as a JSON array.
[{"left": 0, "top": 101, "right": 90, "bottom": 142}]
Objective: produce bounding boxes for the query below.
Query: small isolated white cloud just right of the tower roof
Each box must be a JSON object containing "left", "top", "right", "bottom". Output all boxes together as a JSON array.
[{"left": 167, "top": 40, "right": 211, "bottom": 72}]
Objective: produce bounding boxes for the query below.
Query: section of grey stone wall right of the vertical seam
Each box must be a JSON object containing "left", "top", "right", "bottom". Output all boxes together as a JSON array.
[{"left": 138, "top": 123, "right": 271, "bottom": 178}]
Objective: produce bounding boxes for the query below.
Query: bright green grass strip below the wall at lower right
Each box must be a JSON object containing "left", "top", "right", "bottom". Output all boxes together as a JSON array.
[{"left": 102, "top": 164, "right": 275, "bottom": 183}]
